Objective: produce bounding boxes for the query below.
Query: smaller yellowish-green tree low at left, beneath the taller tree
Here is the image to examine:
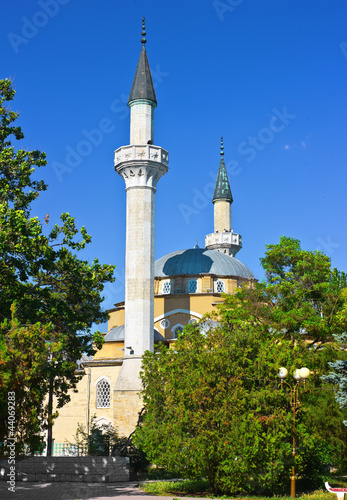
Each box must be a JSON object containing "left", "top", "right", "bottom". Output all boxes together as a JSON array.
[{"left": 0, "top": 306, "right": 61, "bottom": 453}]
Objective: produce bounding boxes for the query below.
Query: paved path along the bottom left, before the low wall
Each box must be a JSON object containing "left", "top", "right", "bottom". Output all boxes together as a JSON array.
[{"left": 0, "top": 481, "right": 216, "bottom": 500}]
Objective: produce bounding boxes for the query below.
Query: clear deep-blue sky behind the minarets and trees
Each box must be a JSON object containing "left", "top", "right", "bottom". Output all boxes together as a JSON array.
[{"left": 0, "top": 0, "right": 347, "bottom": 332}]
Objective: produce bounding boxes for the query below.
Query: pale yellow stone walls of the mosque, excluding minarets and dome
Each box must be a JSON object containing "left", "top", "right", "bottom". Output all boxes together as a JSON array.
[{"left": 53, "top": 276, "right": 247, "bottom": 443}]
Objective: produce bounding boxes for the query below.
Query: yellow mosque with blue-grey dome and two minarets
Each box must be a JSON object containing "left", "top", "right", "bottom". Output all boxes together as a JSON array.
[{"left": 53, "top": 20, "right": 254, "bottom": 454}]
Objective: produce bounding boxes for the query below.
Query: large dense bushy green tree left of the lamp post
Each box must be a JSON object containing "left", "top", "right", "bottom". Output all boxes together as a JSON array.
[{"left": 136, "top": 310, "right": 320, "bottom": 494}]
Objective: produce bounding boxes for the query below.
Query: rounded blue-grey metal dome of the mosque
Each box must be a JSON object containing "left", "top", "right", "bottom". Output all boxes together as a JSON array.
[{"left": 154, "top": 248, "right": 254, "bottom": 279}]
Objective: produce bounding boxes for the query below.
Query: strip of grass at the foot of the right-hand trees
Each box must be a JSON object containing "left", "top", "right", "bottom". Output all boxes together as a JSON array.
[{"left": 140, "top": 476, "right": 347, "bottom": 500}]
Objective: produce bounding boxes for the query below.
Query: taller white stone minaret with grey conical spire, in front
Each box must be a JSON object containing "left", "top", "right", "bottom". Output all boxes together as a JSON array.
[{"left": 114, "top": 18, "right": 168, "bottom": 426}]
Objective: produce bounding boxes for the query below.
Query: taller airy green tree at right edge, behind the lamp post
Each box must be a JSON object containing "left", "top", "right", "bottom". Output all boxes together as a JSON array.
[{"left": 222, "top": 236, "right": 347, "bottom": 468}]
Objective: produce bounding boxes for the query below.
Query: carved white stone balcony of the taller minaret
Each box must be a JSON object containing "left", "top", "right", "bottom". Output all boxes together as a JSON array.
[{"left": 114, "top": 144, "right": 169, "bottom": 189}]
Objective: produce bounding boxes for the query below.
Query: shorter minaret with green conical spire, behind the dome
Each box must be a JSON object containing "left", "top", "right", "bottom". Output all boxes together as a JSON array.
[{"left": 205, "top": 137, "right": 242, "bottom": 257}]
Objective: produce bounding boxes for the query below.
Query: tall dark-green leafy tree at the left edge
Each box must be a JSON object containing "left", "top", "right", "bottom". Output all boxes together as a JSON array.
[{"left": 0, "top": 80, "right": 114, "bottom": 454}]
